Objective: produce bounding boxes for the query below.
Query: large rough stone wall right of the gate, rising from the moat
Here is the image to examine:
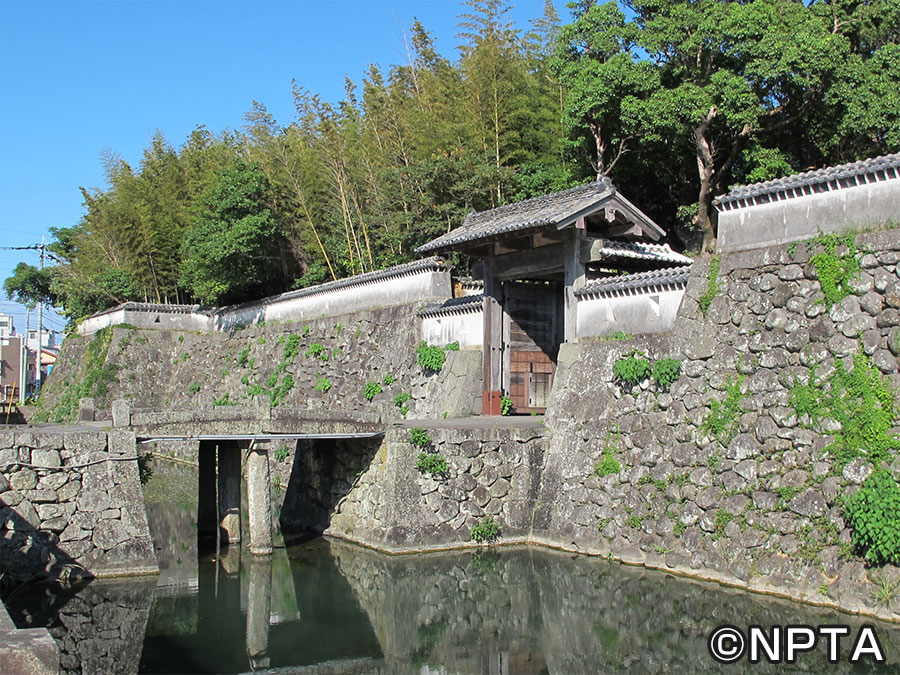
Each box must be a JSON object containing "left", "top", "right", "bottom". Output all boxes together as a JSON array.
[{"left": 535, "top": 231, "right": 900, "bottom": 618}]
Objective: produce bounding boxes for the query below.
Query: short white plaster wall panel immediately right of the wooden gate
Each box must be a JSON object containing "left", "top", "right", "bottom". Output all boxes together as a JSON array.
[{"left": 575, "top": 289, "right": 684, "bottom": 339}]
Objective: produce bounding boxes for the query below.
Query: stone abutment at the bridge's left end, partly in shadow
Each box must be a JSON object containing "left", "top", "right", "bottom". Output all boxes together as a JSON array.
[{"left": 0, "top": 430, "right": 157, "bottom": 579}]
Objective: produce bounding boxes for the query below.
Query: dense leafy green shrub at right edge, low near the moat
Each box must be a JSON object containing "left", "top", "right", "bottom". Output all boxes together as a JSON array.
[{"left": 844, "top": 470, "right": 900, "bottom": 565}]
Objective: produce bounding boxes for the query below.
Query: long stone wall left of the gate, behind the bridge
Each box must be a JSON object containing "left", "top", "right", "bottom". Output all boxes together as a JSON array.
[{"left": 37, "top": 305, "right": 481, "bottom": 421}]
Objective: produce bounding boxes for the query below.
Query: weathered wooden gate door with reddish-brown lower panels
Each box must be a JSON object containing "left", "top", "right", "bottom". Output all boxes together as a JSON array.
[{"left": 503, "top": 282, "right": 559, "bottom": 414}]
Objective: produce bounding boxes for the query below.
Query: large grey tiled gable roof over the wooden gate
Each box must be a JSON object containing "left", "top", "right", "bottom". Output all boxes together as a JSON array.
[{"left": 416, "top": 178, "right": 663, "bottom": 253}]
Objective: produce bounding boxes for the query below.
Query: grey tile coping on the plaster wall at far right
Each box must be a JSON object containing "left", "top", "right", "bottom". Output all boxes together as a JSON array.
[{"left": 715, "top": 153, "right": 900, "bottom": 210}]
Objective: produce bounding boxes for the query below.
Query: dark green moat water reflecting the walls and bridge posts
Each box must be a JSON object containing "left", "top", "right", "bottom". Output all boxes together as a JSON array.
[{"left": 7, "top": 456, "right": 900, "bottom": 675}]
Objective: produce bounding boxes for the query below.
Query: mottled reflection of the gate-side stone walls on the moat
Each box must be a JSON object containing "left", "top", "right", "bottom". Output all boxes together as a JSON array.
[{"left": 331, "top": 543, "right": 900, "bottom": 674}]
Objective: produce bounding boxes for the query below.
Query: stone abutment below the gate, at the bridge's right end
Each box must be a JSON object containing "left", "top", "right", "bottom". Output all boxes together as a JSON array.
[{"left": 273, "top": 426, "right": 543, "bottom": 551}]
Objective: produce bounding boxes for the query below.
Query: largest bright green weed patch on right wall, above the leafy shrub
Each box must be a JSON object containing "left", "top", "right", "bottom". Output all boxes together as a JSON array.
[{"left": 788, "top": 349, "right": 900, "bottom": 466}]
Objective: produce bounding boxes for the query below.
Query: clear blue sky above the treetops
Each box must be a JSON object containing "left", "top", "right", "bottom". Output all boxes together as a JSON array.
[{"left": 0, "top": 0, "right": 569, "bottom": 331}]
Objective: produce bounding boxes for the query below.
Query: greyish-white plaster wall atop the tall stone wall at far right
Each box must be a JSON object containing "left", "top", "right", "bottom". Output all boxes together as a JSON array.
[{"left": 718, "top": 179, "right": 900, "bottom": 251}]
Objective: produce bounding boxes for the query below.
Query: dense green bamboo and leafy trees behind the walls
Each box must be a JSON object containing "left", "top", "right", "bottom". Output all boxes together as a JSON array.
[{"left": 4, "top": 0, "right": 900, "bottom": 320}]
